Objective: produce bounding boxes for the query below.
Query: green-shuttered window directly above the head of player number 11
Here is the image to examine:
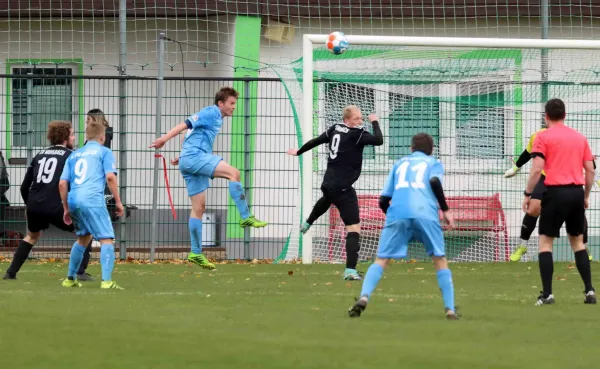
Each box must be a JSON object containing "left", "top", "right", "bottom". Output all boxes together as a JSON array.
[{"left": 388, "top": 87, "right": 440, "bottom": 160}]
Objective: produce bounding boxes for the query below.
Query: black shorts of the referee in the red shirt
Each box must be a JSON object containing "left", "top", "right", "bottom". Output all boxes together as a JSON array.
[{"left": 539, "top": 186, "right": 585, "bottom": 238}]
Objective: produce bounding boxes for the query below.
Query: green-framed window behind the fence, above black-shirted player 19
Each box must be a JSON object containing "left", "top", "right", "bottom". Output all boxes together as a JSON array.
[{"left": 12, "top": 67, "right": 74, "bottom": 147}]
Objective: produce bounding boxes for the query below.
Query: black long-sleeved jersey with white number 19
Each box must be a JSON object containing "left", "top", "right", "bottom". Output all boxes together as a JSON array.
[{"left": 21, "top": 145, "right": 72, "bottom": 214}]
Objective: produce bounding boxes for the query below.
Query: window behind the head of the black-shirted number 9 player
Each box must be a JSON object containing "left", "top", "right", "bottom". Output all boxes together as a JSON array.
[{"left": 324, "top": 82, "right": 375, "bottom": 160}]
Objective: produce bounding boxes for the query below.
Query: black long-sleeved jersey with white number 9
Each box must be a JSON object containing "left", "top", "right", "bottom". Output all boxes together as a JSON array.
[{"left": 298, "top": 122, "right": 383, "bottom": 189}]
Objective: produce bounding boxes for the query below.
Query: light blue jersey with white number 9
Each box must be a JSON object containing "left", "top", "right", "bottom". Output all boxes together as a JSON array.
[{"left": 60, "top": 141, "right": 117, "bottom": 208}]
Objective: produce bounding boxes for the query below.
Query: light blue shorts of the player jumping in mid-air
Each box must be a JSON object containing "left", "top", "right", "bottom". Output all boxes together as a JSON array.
[{"left": 179, "top": 154, "right": 223, "bottom": 197}]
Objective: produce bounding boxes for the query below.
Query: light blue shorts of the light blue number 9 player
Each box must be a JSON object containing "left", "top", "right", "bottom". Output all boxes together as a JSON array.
[{"left": 69, "top": 206, "right": 115, "bottom": 240}]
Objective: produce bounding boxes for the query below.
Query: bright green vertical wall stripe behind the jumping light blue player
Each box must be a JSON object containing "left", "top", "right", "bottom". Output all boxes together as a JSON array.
[{"left": 227, "top": 16, "right": 264, "bottom": 239}]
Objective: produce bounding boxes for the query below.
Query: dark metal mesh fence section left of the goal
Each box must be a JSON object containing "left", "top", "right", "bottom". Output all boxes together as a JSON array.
[{"left": 0, "top": 73, "right": 299, "bottom": 259}]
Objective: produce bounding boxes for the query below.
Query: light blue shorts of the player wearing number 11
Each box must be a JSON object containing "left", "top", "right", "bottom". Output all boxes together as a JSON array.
[{"left": 377, "top": 219, "right": 446, "bottom": 259}]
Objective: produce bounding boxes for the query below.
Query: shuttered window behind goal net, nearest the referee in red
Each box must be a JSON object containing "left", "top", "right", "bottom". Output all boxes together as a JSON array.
[{"left": 456, "top": 82, "right": 505, "bottom": 159}]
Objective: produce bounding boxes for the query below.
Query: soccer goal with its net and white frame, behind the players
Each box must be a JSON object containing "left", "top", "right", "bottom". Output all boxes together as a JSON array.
[{"left": 274, "top": 35, "right": 600, "bottom": 263}]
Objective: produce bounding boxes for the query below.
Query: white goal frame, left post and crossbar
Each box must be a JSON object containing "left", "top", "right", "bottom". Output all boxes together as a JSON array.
[{"left": 300, "top": 34, "right": 600, "bottom": 264}]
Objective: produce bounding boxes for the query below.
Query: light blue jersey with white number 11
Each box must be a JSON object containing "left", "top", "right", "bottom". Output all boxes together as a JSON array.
[{"left": 381, "top": 151, "right": 444, "bottom": 222}]
